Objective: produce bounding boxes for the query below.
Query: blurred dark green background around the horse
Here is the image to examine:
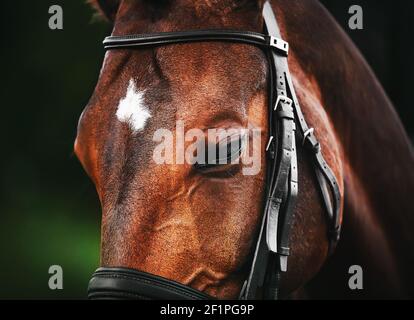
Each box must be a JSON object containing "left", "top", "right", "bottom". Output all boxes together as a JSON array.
[{"left": 0, "top": 0, "right": 414, "bottom": 298}]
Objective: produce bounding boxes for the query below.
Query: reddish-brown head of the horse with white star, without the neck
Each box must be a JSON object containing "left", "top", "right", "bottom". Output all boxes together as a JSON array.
[{"left": 75, "top": 0, "right": 339, "bottom": 298}]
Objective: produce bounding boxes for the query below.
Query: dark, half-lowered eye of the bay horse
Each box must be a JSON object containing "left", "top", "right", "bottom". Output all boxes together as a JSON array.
[{"left": 195, "top": 134, "right": 247, "bottom": 170}]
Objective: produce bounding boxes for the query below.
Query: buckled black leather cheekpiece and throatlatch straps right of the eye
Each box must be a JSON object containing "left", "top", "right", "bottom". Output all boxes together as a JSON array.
[{"left": 240, "top": 1, "right": 341, "bottom": 299}]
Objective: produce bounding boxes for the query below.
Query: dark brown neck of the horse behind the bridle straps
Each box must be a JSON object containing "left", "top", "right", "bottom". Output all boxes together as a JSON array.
[{"left": 275, "top": 0, "right": 414, "bottom": 296}]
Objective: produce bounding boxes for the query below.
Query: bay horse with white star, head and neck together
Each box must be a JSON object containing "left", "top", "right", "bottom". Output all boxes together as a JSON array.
[{"left": 74, "top": 0, "right": 414, "bottom": 299}]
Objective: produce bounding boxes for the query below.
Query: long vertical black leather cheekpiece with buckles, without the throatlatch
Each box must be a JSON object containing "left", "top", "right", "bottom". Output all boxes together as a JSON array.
[{"left": 240, "top": 2, "right": 298, "bottom": 299}]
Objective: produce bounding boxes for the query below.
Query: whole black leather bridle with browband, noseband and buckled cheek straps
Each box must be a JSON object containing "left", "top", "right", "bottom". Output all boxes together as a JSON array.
[{"left": 88, "top": 1, "right": 341, "bottom": 300}]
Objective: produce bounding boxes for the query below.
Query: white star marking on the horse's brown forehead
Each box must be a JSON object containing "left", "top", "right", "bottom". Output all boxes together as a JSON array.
[{"left": 116, "top": 79, "right": 151, "bottom": 133}]
